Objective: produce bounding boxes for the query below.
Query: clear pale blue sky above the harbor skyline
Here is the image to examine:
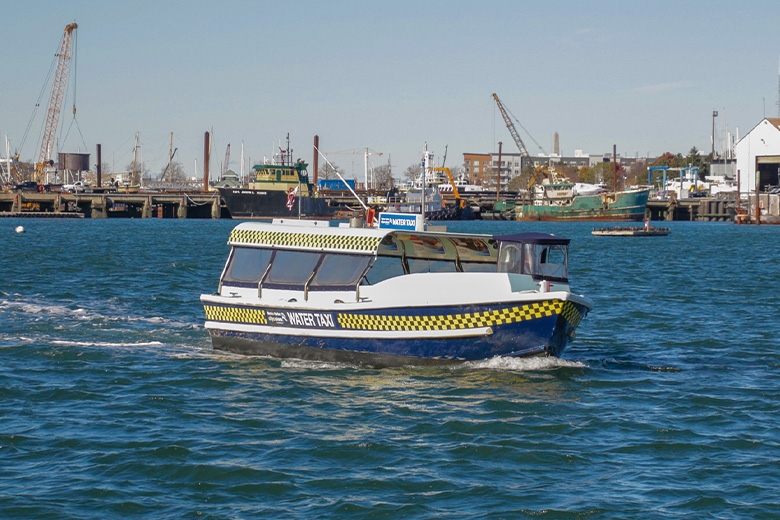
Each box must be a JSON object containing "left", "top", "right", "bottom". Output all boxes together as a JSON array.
[{"left": 0, "top": 0, "right": 780, "bottom": 179}]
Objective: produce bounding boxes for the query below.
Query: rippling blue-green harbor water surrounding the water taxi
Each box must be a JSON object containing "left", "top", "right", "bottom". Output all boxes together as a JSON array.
[{"left": 0, "top": 219, "right": 780, "bottom": 519}]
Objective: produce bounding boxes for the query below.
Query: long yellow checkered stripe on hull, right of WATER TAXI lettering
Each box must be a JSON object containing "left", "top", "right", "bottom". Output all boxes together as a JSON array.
[{"left": 337, "top": 300, "right": 564, "bottom": 330}]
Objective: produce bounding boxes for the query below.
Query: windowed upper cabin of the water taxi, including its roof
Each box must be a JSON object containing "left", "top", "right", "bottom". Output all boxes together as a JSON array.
[{"left": 219, "top": 217, "right": 569, "bottom": 300}]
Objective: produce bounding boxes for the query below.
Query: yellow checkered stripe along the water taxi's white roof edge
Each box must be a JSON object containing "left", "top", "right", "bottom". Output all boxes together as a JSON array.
[{"left": 230, "top": 229, "right": 382, "bottom": 251}]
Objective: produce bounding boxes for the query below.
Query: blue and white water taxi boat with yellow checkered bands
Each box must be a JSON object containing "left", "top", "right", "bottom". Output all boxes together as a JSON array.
[{"left": 201, "top": 213, "right": 592, "bottom": 368}]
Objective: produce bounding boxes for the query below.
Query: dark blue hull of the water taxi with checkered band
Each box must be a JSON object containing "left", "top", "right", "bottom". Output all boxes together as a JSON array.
[{"left": 206, "top": 300, "right": 587, "bottom": 368}]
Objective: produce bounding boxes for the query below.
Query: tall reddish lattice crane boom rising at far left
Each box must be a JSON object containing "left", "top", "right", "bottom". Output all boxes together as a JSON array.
[{"left": 35, "top": 22, "right": 78, "bottom": 183}]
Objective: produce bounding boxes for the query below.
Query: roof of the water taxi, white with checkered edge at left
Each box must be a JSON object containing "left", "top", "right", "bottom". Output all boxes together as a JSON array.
[{"left": 228, "top": 219, "right": 569, "bottom": 254}]
